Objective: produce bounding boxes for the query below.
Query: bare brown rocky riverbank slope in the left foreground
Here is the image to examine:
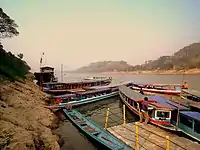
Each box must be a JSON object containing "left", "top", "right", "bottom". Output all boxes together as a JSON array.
[{"left": 0, "top": 80, "right": 60, "bottom": 150}]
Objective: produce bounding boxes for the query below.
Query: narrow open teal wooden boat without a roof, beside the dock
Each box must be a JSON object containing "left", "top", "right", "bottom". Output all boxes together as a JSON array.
[{"left": 63, "top": 109, "right": 131, "bottom": 150}]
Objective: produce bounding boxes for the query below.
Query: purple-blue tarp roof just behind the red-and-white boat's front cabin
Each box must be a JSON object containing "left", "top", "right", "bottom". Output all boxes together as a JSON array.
[{"left": 148, "top": 96, "right": 189, "bottom": 110}]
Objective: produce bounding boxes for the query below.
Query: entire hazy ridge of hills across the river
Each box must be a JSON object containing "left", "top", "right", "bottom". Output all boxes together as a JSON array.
[{"left": 75, "top": 43, "right": 200, "bottom": 72}]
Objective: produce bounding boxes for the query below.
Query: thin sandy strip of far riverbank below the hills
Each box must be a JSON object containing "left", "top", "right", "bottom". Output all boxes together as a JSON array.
[{"left": 102, "top": 68, "right": 200, "bottom": 75}]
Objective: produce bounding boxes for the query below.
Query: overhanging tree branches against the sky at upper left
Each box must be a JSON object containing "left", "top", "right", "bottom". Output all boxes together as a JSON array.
[{"left": 0, "top": 8, "right": 19, "bottom": 39}]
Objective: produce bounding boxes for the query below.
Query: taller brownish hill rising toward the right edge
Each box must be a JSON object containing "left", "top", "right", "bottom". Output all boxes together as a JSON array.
[{"left": 132, "top": 43, "right": 200, "bottom": 71}]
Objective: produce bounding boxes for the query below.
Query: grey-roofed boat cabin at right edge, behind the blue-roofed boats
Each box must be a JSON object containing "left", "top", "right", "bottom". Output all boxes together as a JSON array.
[{"left": 181, "top": 89, "right": 200, "bottom": 102}]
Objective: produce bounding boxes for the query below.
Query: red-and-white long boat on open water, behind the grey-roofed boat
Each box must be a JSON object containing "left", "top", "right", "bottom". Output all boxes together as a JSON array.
[{"left": 131, "top": 83, "right": 181, "bottom": 95}]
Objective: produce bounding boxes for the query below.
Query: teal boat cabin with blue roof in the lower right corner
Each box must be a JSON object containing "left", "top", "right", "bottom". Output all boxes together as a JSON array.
[{"left": 178, "top": 111, "right": 200, "bottom": 142}]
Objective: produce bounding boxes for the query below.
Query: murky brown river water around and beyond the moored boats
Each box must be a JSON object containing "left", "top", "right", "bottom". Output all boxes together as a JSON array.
[{"left": 53, "top": 74, "right": 200, "bottom": 150}]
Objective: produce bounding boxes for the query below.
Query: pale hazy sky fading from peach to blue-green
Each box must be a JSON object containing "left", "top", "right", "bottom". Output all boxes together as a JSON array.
[{"left": 0, "top": 0, "right": 200, "bottom": 70}]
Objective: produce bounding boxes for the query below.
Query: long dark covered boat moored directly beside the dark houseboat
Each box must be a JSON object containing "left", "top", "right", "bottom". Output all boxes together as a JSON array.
[{"left": 43, "top": 77, "right": 112, "bottom": 95}]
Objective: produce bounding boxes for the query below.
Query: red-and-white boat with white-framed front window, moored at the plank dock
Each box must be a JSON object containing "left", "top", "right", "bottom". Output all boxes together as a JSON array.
[{"left": 119, "top": 86, "right": 189, "bottom": 131}]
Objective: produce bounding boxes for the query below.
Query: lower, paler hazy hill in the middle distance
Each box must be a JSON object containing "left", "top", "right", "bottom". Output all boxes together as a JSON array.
[{"left": 75, "top": 61, "right": 132, "bottom": 73}]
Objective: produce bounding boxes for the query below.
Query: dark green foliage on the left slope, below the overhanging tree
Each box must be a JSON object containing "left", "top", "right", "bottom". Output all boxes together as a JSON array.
[{"left": 0, "top": 49, "right": 30, "bottom": 81}]
